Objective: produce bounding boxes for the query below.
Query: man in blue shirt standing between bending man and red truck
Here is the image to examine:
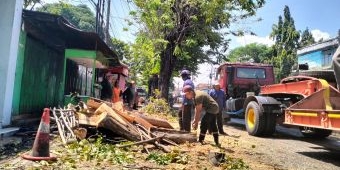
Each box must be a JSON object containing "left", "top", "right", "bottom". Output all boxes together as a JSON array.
[{"left": 209, "top": 81, "right": 226, "bottom": 135}]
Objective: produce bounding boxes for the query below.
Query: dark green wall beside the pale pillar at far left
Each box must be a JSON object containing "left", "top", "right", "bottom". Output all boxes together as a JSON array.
[{"left": 12, "top": 33, "right": 64, "bottom": 116}]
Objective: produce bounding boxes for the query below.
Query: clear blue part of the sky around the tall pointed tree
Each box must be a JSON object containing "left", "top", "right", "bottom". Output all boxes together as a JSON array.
[{"left": 254, "top": 0, "right": 340, "bottom": 37}]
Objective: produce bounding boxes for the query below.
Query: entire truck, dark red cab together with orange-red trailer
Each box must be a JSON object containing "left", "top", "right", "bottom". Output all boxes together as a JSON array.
[{"left": 219, "top": 58, "right": 340, "bottom": 138}]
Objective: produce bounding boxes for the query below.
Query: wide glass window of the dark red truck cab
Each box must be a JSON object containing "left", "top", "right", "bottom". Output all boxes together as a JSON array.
[{"left": 236, "top": 68, "right": 266, "bottom": 79}]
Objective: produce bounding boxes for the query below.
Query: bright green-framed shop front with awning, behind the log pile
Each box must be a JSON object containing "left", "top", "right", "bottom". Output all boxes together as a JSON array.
[{"left": 64, "top": 49, "right": 127, "bottom": 104}]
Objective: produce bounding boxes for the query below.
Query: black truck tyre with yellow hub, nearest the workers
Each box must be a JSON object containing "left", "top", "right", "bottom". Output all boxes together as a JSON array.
[{"left": 245, "top": 101, "right": 266, "bottom": 136}]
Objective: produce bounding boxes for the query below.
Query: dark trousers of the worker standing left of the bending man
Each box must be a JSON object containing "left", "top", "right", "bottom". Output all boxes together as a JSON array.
[{"left": 178, "top": 104, "right": 192, "bottom": 132}]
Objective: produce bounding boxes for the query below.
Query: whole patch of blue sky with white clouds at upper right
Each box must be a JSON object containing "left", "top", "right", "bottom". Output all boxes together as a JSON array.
[{"left": 231, "top": 0, "right": 340, "bottom": 48}]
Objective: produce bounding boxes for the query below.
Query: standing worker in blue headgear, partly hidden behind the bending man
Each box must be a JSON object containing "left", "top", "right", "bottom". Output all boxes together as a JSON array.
[{"left": 178, "top": 69, "right": 195, "bottom": 132}]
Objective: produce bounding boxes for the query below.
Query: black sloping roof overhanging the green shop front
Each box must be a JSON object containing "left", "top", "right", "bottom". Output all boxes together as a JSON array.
[{"left": 22, "top": 10, "right": 122, "bottom": 67}]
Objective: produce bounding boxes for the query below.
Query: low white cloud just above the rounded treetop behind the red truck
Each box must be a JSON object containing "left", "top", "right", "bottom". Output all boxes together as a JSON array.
[{"left": 236, "top": 35, "right": 274, "bottom": 46}]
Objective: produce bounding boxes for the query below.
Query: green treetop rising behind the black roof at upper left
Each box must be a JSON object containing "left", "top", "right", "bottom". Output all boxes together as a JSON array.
[{"left": 37, "top": 1, "right": 96, "bottom": 32}]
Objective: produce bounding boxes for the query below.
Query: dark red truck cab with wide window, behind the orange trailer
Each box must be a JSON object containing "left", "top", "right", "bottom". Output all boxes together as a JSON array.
[{"left": 217, "top": 62, "right": 274, "bottom": 117}]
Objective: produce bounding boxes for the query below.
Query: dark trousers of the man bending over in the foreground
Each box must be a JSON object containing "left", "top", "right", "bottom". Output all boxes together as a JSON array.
[{"left": 198, "top": 113, "right": 219, "bottom": 145}]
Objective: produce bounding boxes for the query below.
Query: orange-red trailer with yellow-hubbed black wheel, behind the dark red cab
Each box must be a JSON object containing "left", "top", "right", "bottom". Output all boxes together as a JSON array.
[{"left": 244, "top": 76, "right": 340, "bottom": 138}]
